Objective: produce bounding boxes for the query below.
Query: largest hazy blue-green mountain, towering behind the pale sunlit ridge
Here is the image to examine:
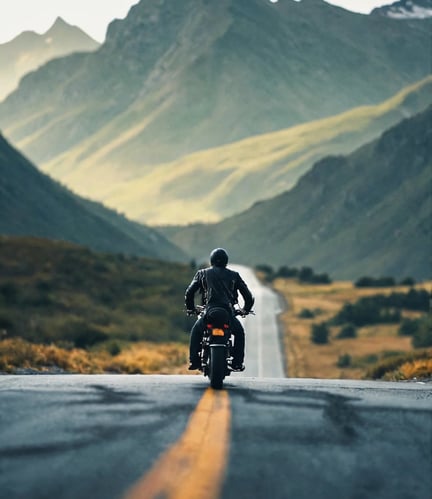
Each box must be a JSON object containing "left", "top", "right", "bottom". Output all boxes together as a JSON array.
[{"left": 0, "top": 0, "right": 431, "bottom": 221}]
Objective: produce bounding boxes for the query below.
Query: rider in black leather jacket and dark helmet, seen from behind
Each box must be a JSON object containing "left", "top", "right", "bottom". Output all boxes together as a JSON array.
[{"left": 185, "top": 248, "right": 254, "bottom": 371}]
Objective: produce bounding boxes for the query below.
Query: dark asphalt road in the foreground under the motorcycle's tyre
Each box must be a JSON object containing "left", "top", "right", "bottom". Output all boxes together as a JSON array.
[{"left": 0, "top": 375, "right": 432, "bottom": 499}]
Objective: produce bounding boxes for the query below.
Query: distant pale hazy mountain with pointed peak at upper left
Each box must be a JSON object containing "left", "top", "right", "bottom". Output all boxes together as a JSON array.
[{"left": 0, "top": 17, "right": 99, "bottom": 101}]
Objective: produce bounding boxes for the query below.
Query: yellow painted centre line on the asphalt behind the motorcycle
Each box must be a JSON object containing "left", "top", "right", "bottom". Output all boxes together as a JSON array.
[{"left": 124, "top": 388, "right": 231, "bottom": 499}]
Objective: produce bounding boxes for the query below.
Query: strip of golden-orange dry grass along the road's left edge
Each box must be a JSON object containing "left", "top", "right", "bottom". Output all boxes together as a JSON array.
[{"left": 0, "top": 338, "right": 188, "bottom": 374}]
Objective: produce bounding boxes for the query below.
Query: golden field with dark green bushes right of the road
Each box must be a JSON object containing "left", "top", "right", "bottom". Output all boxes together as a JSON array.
[{"left": 272, "top": 274, "right": 432, "bottom": 380}]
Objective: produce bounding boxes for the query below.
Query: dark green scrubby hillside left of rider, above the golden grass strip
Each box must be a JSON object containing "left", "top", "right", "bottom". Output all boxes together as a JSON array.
[{"left": 0, "top": 237, "right": 193, "bottom": 350}]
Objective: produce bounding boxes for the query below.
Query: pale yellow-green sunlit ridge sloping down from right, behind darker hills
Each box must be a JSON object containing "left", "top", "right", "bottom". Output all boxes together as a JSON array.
[{"left": 45, "top": 77, "right": 432, "bottom": 224}]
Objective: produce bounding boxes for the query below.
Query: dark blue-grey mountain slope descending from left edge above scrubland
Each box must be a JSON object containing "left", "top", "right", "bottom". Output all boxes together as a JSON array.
[{"left": 0, "top": 135, "right": 185, "bottom": 261}]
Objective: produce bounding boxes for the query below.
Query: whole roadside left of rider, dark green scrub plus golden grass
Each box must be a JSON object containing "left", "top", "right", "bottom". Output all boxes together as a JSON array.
[{"left": 0, "top": 237, "right": 193, "bottom": 373}]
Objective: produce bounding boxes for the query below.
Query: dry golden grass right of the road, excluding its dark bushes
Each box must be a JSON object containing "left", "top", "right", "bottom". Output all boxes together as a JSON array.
[{"left": 274, "top": 279, "right": 430, "bottom": 379}]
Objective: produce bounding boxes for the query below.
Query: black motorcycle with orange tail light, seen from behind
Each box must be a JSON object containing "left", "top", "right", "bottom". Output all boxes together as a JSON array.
[{"left": 191, "top": 306, "right": 254, "bottom": 389}]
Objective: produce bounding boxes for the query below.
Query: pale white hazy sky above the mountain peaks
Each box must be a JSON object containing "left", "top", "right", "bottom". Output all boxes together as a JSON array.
[{"left": 0, "top": 0, "right": 393, "bottom": 43}]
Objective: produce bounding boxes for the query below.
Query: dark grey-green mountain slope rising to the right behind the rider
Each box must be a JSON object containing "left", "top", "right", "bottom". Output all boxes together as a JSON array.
[{"left": 164, "top": 106, "right": 432, "bottom": 279}]
